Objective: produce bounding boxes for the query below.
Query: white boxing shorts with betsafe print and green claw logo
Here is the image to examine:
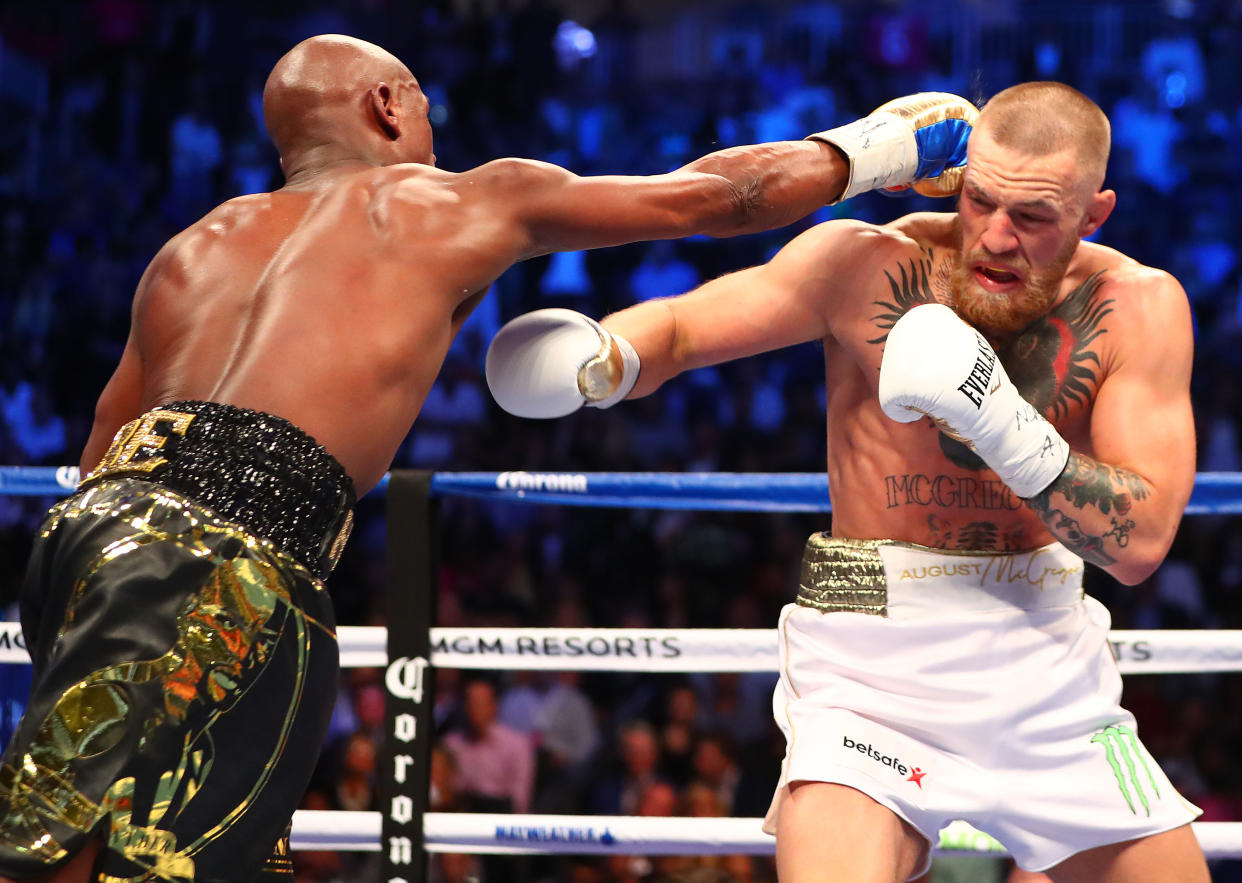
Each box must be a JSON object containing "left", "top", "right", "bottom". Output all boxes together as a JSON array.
[{"left": 764, "top": 534, "right": 1200, "bottom": 879}]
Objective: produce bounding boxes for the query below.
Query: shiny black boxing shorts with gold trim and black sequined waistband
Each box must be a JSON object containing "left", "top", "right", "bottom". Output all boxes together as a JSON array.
[{"left": 0, "top": 402, "right": 354, "bottom": 883}]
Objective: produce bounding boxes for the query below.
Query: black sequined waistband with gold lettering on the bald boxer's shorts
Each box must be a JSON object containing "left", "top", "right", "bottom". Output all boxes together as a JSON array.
[{"left": 81, "top": 401, "right": 355, "bottom": 577}]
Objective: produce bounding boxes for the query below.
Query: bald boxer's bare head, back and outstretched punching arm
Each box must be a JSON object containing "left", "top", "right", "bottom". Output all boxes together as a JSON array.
[{"left": 82, "top": 36, "right": 847, "bottom": 494}]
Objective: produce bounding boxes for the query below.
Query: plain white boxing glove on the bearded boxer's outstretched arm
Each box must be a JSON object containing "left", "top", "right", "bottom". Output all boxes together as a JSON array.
[{"left": 486, "top": 308, "right": 640, "bottom": 419}]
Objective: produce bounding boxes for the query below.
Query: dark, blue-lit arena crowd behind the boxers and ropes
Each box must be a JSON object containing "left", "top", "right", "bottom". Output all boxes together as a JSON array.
[{"left": 0, "top": 0, "right": 1242, "bottom": 883}]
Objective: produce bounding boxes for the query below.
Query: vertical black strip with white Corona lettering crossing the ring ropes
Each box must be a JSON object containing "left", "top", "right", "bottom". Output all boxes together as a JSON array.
[{"left": 379, "top": 469, "right": 440, "bottom": 883}]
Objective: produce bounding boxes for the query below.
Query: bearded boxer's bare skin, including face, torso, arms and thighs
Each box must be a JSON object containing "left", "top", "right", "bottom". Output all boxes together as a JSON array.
[{"left": 601, "top": 115, "right": 1208, "bottom": 883}]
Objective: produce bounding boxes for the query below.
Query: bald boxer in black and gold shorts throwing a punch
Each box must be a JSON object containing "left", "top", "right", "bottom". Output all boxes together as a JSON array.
[{"left": 0, "top": 35, "right": 969, "bottom": 883}]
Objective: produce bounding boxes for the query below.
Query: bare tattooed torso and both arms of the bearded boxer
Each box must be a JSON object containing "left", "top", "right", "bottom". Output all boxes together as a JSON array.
[{"left": 602, "top": 192, "right": 1194, "bottom": 582}]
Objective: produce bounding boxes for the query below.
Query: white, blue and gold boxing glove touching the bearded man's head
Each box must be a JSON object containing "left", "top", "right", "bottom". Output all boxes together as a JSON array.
[{"left": 807, "top": 92, "right": 979, "bottom": 201}]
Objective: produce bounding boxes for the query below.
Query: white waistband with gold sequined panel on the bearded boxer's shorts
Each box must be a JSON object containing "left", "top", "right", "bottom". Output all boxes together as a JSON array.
[{"left": 796, "top": 533, "right": 1083, "bottom": 618}]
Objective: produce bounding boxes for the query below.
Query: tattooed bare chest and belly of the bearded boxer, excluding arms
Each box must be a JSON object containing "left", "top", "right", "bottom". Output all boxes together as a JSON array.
[{"left": 825, "top": 214, "right": 1145, "bottom": 550}]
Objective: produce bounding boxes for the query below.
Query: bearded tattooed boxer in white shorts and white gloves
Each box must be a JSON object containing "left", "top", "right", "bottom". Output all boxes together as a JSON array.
[{"left": 488, "top": 82, "right": 1208, "bottom": 883}]
